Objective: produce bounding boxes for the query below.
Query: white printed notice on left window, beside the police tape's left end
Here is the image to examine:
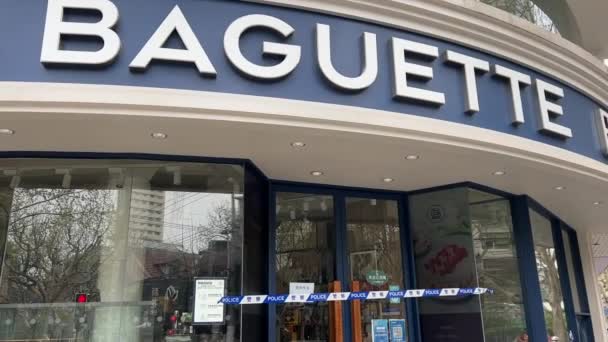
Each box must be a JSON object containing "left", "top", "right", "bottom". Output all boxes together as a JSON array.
[{"left": 192, "top": 278, "right": 225, "bottom": 324}]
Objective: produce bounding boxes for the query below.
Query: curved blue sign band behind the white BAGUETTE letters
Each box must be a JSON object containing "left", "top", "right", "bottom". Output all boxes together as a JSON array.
[{"left": 0, "top": 0, "right": 608, "bottom": 163}]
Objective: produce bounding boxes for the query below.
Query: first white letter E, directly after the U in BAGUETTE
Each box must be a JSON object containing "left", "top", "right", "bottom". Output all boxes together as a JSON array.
[{"left": 392, "top": 37, "right": 445, "bottom": 105}]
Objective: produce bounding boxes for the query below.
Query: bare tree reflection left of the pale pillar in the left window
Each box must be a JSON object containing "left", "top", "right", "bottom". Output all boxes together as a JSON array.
[{"left": 0, "top": 189, "right": 115, "bottom": 303}]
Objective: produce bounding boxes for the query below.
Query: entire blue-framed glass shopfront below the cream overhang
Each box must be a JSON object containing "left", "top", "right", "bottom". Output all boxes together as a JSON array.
[{"left": 0, "top": 159, "right": 592, "bottom": 342}]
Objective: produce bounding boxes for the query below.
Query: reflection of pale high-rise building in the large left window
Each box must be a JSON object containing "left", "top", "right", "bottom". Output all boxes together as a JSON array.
[{"left": 129, "top": 189, "right": 165, "bottom": 241}]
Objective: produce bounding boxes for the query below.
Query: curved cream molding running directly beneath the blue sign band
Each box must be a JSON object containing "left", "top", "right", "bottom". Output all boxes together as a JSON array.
[{"left": 0, "top": 82, "right": 608, "bottom": 183}]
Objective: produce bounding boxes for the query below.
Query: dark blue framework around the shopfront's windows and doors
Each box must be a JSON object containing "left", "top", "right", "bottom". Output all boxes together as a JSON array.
[{"left": 0, "top": 151, "right": 593, "bottom": 341}]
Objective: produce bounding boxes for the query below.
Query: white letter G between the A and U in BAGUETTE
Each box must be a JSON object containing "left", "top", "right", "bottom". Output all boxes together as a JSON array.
[{"left": 224, "top": 14, "right": 301, "bottom": 80}]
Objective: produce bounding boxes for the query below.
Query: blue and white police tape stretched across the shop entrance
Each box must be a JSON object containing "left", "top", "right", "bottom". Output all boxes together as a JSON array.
[{"left": 218, "top": 287, "right": 494, "bottom": 305}]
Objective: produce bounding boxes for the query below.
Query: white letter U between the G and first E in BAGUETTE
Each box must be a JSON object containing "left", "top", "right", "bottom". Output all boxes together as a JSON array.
[{"left": 317, "top": 24, "right": 378, "bottom": 91}]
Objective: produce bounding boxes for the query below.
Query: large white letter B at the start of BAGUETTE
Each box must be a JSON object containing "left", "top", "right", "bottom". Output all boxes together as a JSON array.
[{"left": 40, "top": 0, "right": 120, "bottom": 65}]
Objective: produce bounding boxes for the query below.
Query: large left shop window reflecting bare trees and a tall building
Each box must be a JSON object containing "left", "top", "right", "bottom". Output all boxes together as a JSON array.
[{"left": 0, "top": 160, "right": 243, "bottom": 342}]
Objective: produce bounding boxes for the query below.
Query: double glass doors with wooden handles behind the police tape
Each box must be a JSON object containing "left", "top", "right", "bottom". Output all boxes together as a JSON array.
[{"left": 270, "top": 186, "right": 413, "bottom": 342}]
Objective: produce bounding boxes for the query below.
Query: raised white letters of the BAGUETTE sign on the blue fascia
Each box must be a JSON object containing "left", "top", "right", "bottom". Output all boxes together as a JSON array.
[{"left": 26, "top": 0, "right": 608, "bottom": 155}]
